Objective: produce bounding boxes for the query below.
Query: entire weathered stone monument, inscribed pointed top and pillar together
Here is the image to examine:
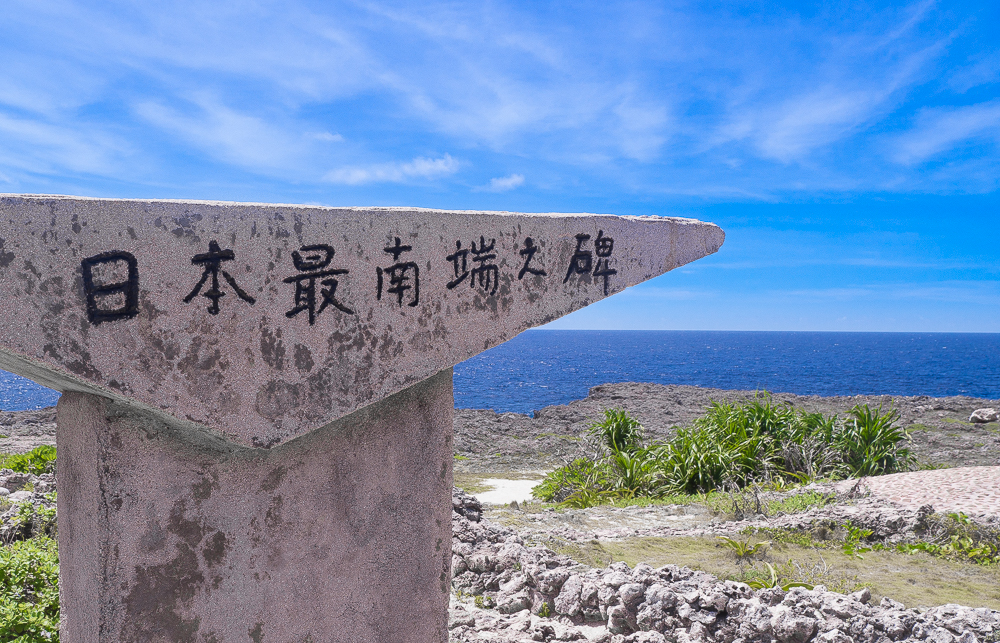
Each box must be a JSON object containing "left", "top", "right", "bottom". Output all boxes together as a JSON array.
[{"left": 0, "top": 195, "right": 723, "bottom": 643}]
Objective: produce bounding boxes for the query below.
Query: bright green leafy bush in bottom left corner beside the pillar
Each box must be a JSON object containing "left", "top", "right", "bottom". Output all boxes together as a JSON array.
[{"left": 0, "top": 537, "right": 59, "bottom": 643}]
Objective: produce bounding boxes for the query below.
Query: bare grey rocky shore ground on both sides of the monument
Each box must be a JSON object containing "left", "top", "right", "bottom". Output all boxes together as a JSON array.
[{"left": 0, "top": 383, "right": 1000, "bottom": 643}]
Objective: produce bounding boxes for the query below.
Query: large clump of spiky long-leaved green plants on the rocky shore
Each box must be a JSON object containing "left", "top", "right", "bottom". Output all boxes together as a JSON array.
[{"left": 533, "top": 393, "right": 915, "bottom": 513}]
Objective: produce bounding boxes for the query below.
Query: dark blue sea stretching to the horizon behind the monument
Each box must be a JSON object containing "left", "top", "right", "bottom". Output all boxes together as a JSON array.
[{"left": 0, "top": 330, "right": 1000, "bottom": 413}]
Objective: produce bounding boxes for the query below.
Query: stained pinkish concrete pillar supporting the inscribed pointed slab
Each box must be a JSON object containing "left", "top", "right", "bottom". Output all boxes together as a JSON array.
[{"left": 57, "top": 368, "right": 454, "bottom": 643}]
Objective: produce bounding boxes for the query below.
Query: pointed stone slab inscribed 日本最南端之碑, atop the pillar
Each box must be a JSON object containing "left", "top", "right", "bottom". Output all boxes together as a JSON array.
[{"left": 0, "top": 195, "right": 723, "bottom": 447}]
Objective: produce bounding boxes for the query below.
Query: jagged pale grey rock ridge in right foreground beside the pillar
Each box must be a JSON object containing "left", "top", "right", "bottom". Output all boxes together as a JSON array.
[{"left": 450, "top": 490, "right": 1000, "bottom": 643}]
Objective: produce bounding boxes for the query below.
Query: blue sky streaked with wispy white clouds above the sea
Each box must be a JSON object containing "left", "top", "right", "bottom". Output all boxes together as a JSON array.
[{"left": 0, "top": 0, "right": 1000, "bottom": 332}]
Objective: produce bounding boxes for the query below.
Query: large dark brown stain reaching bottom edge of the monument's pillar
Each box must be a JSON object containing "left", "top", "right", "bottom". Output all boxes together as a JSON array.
[{"left": 122, "top": 543, "right": 205, "bottom": 643}]
